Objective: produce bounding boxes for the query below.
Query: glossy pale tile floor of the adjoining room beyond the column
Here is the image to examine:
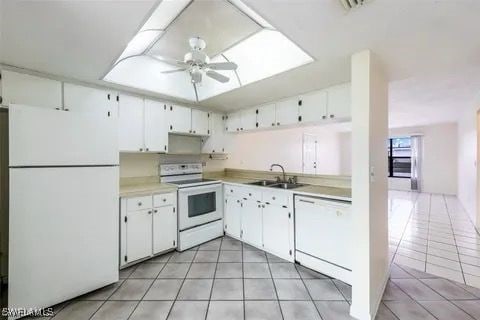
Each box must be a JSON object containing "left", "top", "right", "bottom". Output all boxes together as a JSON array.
[{"left": 389, "top": 191, "right": 480, "bottom": 288}]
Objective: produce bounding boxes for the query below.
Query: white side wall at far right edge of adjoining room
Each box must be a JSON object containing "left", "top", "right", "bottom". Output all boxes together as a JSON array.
[{"left": 457, "top": 99, "right": 480, "bottom": 227}]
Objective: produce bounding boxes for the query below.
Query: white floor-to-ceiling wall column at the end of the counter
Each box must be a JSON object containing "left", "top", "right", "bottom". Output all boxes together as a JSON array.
[{"left": 350, "top": 50, "right": 389, "bottom": 320}]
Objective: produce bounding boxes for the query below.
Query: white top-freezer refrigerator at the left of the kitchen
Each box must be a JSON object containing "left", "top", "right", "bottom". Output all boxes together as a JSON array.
[{"left": 8, "top": 105, "right": 119, "bottom": 316}]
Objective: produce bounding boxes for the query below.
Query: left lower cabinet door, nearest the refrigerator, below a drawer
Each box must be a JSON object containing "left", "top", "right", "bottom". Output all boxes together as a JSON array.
[{"left": 124, "top": 209, "right": 152, "bottom": 263}]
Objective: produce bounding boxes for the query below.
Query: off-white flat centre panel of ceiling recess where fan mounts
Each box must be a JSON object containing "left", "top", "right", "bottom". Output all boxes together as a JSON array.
[{"left": 150, "top": 1, "right": 261, "bottom": 60}]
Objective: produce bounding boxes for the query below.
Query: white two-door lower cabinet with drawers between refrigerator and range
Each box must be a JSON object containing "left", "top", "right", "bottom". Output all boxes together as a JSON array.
[{"left": 120, "top": 192, "right": 177, "bottom": 267}]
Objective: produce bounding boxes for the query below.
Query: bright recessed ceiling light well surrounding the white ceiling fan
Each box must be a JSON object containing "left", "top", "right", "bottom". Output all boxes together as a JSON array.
[{"left": 103, "top": 0, "right": 313, "bottom": 102}]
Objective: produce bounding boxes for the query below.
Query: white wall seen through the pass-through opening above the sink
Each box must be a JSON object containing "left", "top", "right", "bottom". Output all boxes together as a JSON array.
[{"left": 226, "top": 124, "right": 341, "bottom": 175}]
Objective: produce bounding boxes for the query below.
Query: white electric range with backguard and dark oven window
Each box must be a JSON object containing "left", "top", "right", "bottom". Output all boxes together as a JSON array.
[{"left": 160, "top": 163, "right": 223, "bottom": 251}]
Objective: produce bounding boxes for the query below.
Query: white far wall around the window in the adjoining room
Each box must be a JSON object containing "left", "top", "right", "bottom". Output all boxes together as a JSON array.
[{"left": 340, "top": 123, "right": 458, "bottom": 195}]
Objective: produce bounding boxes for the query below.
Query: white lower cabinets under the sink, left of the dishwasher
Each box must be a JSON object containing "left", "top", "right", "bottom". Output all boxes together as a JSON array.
[{"left": 224, "top": 184, "right": 294, "bottom": 261}]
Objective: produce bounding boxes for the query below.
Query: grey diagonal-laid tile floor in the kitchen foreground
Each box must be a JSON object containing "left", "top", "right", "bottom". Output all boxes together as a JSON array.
[{"left": 31, "top": 237, "right": 480, "bottom": 320}]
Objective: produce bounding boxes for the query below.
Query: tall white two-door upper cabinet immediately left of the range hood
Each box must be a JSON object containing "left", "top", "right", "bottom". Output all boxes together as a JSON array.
[{"left": 118, "top": 94, "right": 168, "bottom": 152}]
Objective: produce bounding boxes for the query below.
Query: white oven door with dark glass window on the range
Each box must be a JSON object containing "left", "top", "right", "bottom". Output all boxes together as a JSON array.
[{"left": 178, "top": 183, "right": 223, "bottom": 231}]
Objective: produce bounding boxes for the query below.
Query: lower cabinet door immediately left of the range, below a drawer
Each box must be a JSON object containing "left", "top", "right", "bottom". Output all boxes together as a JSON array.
[{"left": 153, "top": 206, "right": 177, "bottom": 254}]
